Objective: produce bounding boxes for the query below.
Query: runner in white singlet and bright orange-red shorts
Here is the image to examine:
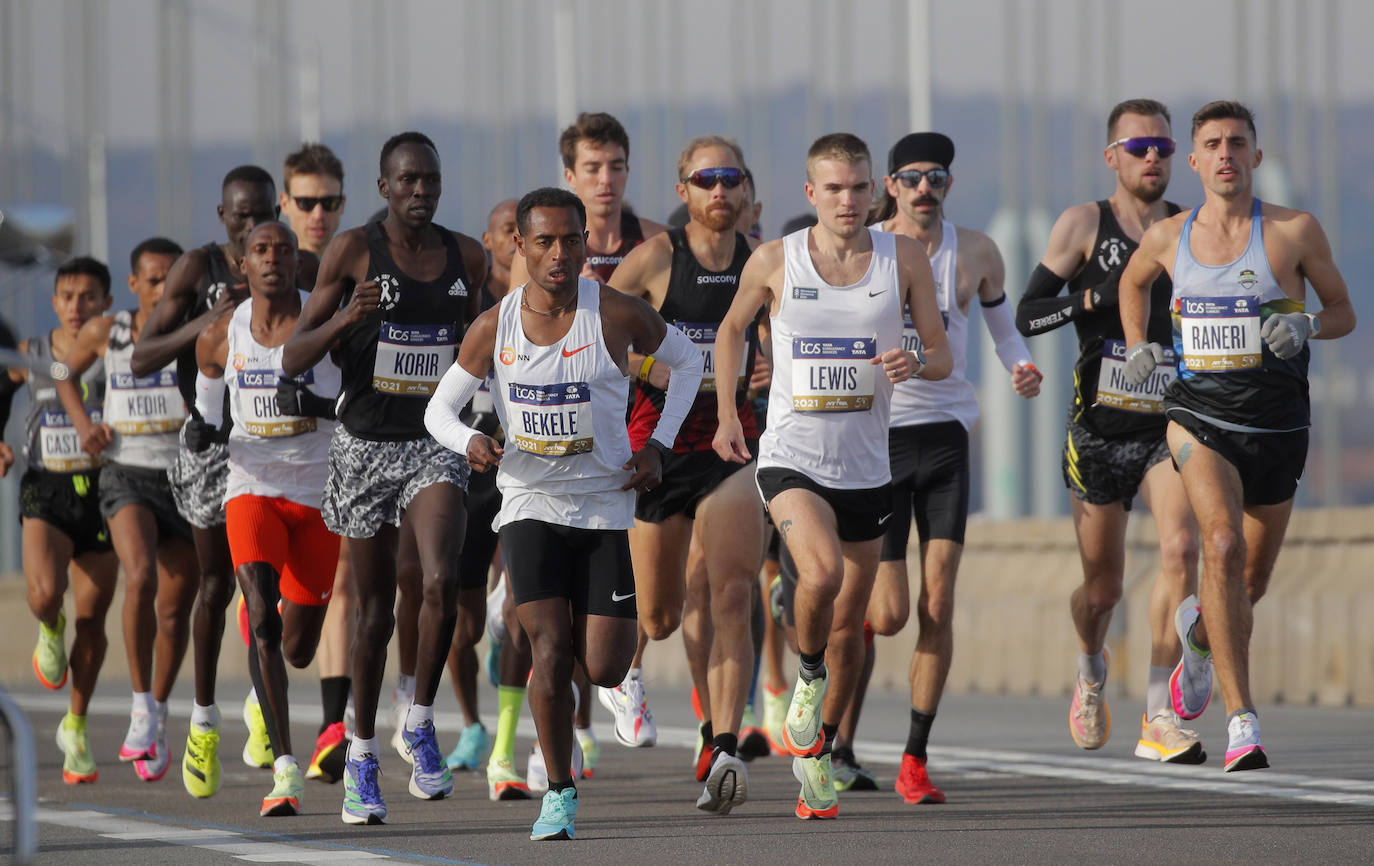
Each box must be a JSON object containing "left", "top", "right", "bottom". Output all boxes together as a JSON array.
[{"left": 185, "top": 223, "right": 339, "bottom": 817}]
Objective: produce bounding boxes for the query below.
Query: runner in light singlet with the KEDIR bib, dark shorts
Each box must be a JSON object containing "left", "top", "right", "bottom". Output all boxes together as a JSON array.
[{"left": 56, "top": 238, "right": 198, "bottom": 782}]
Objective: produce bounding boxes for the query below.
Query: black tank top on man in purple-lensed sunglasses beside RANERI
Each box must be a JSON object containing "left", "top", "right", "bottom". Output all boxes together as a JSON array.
[{"left": 1069, "top": 199, "right": 1180, "bottom": 438}]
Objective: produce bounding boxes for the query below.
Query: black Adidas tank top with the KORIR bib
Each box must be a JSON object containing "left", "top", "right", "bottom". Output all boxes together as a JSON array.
[{"left": 338, "top": 223, "right": 470, "bottom": 440}]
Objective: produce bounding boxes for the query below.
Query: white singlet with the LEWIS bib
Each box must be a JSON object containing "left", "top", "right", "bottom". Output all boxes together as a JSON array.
[{"left": 758, "top": 228, "right": 901, "bottom": 489}]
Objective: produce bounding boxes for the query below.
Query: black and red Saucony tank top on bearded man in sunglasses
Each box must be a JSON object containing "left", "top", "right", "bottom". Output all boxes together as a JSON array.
[{"left": 629, "top": 228, "right": 758, "bottom": 454}]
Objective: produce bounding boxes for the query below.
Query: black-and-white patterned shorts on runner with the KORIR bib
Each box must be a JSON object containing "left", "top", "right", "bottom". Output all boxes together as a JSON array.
[{"left": 320, "top": 425, "right": 471, "bottom": 539}]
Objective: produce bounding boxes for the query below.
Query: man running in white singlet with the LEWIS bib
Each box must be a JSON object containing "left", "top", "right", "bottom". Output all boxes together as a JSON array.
[{"left": 714, "top": 133, "right": 952, "bottom": 818}]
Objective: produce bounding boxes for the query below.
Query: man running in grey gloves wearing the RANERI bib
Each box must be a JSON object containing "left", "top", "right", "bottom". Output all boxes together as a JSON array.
[{"left": 1121, "top": 102, "right": 1355, "bottom": 773}]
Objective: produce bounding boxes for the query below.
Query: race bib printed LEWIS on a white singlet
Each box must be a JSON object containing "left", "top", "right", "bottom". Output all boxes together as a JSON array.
[{"left": 791, "top": 337, "right": 878, "bottom": 412}]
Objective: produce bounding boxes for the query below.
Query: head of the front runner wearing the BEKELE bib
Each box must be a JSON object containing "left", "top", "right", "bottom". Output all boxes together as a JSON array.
[{"left": 515, "top": 187, "right": 587, "bottom": 294}]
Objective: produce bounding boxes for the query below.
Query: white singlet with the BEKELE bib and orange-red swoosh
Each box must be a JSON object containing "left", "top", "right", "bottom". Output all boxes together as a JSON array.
[{"left": 492, "top": 278, "right": 635, "bottom": 529}]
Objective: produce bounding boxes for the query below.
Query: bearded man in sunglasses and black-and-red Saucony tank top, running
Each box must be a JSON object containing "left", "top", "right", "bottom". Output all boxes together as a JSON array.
[{"left": 610, "top": 135, "right": 764, "bottom": 814}]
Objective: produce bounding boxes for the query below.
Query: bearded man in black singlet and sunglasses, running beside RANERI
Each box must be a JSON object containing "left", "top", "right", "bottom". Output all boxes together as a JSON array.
[{"left": 1017, "top": 99, "right": 1206, "bottom": 763}]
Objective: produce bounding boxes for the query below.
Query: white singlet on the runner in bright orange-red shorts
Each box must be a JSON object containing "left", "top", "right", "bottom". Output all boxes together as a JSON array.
[{"left": 224, "top": 291, "right": 341, "bottom": 509}]
